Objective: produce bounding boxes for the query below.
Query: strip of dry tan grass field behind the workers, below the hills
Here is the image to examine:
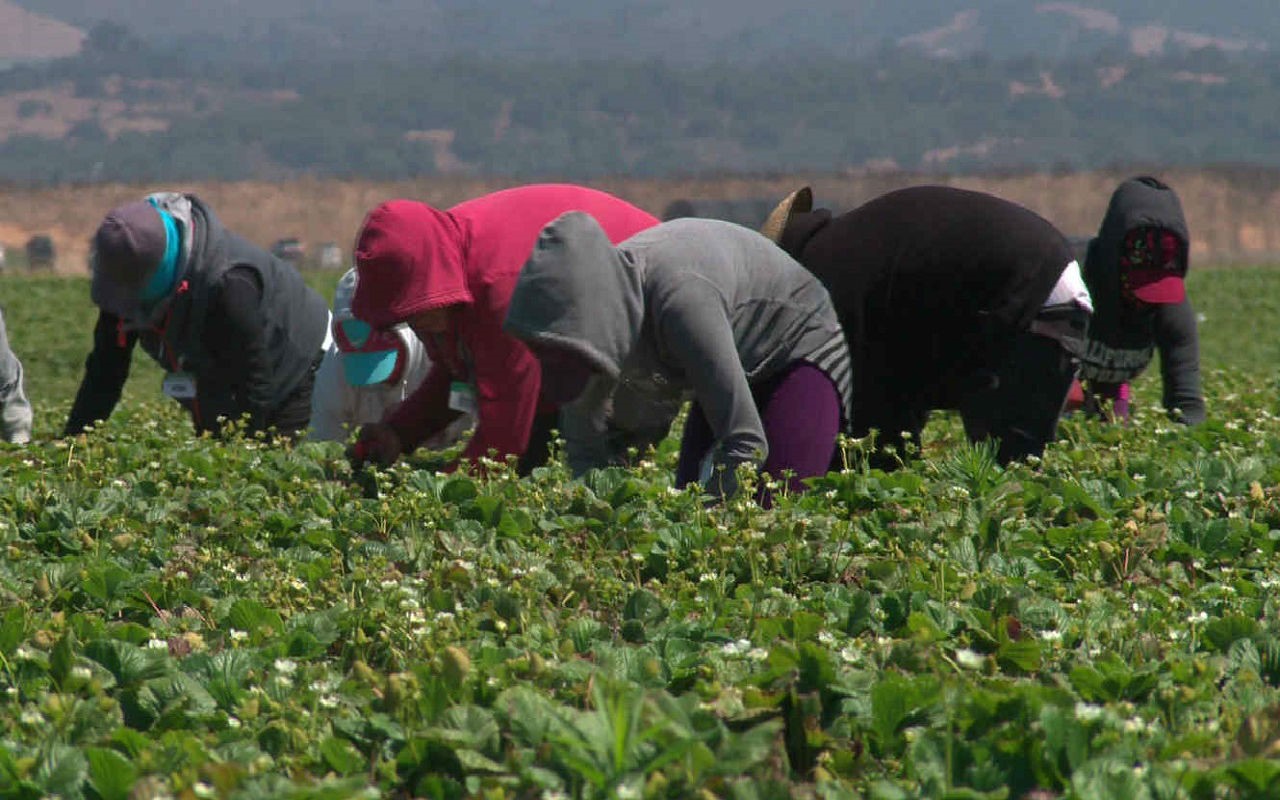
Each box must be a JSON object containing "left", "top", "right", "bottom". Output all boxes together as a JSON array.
[{"left": 0, "top": 168, "right": 1280, "bottom": 273}]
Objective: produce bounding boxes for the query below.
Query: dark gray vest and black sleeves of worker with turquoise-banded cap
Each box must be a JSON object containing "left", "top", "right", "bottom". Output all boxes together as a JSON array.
[{"left": 64, "top": 197, "right": 329, "bottom": 435}]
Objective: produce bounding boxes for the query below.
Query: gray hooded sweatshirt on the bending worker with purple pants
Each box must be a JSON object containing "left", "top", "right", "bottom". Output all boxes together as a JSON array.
[{"left": 506, "top": 211, "right": 852, "bottom": 486}]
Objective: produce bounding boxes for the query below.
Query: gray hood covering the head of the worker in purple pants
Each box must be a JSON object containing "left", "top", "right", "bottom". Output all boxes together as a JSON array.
[{"left": 503, "top": 211, "right": 644, "bottom": 379}]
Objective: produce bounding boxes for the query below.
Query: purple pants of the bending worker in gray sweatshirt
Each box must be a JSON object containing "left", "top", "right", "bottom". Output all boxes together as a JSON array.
[{"left": 676, "top": 361, "right": 840, "bottom": 504}]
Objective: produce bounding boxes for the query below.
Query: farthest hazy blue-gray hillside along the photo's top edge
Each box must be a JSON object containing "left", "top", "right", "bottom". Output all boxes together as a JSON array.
[{"left": 7, "top": 0, "right": 1280, "bottom": 61}]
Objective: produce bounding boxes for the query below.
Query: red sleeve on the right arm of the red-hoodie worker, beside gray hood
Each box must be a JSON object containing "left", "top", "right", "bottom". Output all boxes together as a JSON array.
[{"left": 462, "top": 307, "right": 541, "bottom": 463}]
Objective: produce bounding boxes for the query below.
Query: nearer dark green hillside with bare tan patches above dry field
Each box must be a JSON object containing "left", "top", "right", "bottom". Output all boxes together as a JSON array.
[{"left": 0, "top": 40, "right": 1280, "bottom": 183}]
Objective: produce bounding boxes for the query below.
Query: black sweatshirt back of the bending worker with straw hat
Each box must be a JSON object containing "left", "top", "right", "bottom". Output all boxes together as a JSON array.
[{"left": 781, "top": 187, "right": 1071, "bottom": 399}]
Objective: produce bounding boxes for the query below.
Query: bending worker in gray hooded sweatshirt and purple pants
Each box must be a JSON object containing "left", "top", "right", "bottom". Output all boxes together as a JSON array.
[{"left": 506, "top": 212, "right": 851, "bottom": 499}]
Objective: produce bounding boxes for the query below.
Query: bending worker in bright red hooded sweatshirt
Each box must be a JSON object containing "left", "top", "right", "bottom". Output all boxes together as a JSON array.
[{"left": 351, "top": 184, "right": 675, "bottom": 472}]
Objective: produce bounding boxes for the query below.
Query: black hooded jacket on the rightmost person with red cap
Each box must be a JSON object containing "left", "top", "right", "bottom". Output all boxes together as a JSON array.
[{"left": 1076, "top": 177, "right": 1204, "bottom": 424}]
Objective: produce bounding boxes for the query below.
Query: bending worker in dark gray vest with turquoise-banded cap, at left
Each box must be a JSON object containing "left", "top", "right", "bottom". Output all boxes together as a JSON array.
[{"left": 65, "top": 192, "right": 329, "bottom": 435}]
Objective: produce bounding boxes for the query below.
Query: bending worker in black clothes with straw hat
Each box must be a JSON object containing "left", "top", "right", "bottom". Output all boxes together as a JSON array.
[{"left": 764, "top": 186, "right": 1092, "bottom": 467}]
